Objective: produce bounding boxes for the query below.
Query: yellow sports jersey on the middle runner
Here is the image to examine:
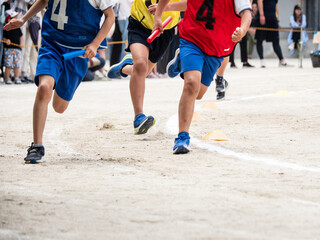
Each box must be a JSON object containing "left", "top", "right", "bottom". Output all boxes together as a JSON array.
[{"left": 130, "top": 0, "right": 180, "bottom": 30}]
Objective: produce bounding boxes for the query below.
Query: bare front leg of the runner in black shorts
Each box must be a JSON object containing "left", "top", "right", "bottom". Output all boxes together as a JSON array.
[{"left": 130, "top": 43, "right": 154, "bottom": 116}]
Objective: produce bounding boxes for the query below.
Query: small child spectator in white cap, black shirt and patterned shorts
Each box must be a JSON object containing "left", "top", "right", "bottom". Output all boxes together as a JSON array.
[{"left": 3, "top": 10, "right": 23, "bottom": 84}]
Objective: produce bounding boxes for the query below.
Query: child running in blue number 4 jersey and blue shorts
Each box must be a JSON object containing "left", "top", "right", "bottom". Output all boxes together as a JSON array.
[{"left": 4, "top": 0, "right": 114, "bottom": 163}]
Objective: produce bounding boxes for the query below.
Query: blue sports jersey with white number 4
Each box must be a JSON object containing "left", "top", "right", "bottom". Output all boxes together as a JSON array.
[{"left": 42, "top": 0, "right": 112, "bottom": 48}]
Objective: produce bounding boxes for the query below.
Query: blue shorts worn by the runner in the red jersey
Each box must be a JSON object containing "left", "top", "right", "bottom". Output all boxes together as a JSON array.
[{"left": 180, "top": 38, "right": 223, "bottom": 87}]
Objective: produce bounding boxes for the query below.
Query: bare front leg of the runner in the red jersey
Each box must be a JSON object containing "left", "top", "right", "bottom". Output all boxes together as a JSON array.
[{"left": 179, "top": 71, "right": 201, "bottom": 133}]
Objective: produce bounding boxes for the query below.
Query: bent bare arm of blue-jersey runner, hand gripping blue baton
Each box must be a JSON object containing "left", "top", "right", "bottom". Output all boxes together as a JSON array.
[{"left": 83, "top": 7, "right": 115, "bottom": 59}]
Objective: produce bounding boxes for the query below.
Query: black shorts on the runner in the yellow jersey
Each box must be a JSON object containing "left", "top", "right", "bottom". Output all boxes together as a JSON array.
[{"left": 126, "top": 17, "right": 174, "bottom": 63}]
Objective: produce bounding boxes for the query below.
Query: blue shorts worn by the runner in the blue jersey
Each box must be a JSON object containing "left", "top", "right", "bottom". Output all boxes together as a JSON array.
[{"left": 35, "top": 38, "right": 88, "bottom": 101}]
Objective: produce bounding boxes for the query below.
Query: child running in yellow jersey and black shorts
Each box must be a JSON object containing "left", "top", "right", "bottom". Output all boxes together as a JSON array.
[{"left": 108, "top": 0, "right": 180, "bottom": 134}]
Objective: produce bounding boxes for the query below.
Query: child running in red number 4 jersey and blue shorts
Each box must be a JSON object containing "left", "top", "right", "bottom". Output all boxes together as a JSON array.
[{"left": 153, "top": 0, "right": 251, "bottom": 154}]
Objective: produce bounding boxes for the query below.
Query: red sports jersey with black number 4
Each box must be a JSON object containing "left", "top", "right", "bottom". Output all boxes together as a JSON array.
[{"left": 179, "top": 0, "right": 241, "bottom": 57}]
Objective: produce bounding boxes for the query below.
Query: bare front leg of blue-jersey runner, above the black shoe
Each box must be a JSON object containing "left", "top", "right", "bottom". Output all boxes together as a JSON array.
[{"left": 33, "top": 75, "right": 54, "bottom": 144}]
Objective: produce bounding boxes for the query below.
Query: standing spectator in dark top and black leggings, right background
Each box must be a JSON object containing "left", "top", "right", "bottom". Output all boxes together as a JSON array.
[{"left": 256, "top": 0, "right": 288, "bottom": 67}]
